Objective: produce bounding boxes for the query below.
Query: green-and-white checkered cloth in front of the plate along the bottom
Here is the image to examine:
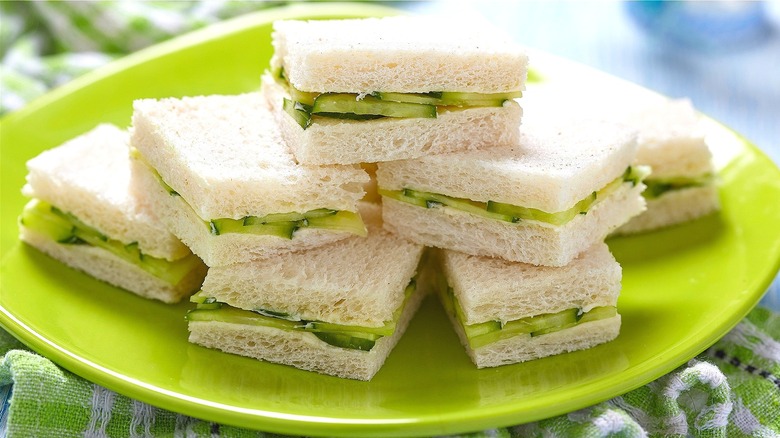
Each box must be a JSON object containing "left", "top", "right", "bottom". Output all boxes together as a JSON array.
[{"left": 0, "top": 307, "right": 780, "bottom": 438}]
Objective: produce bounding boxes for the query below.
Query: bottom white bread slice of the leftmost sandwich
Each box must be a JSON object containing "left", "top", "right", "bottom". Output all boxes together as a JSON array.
[{"left": 19, "top": 226, "right": 207, "bottom": 303}]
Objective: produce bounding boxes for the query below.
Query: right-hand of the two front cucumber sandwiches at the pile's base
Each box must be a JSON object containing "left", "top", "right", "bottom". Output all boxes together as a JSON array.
[{"left": 435, "top": 242, "right": 621, "bottom": 368}]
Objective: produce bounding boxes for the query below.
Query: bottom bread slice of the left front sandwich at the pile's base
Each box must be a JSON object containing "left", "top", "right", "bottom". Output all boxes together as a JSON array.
[{"left": 189, "top": 280, "right": 423, "bottom": 380}]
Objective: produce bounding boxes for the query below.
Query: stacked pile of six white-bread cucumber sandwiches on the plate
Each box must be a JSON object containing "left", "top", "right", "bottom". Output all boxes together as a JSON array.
[{"left": 16, "top": 17, "right": 712, "bottom": 380}]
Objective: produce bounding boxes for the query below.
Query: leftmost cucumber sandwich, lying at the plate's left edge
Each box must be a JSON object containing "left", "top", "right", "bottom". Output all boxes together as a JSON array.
[{"left": 19, "top": 124, "right": 206, "bottom": 303}]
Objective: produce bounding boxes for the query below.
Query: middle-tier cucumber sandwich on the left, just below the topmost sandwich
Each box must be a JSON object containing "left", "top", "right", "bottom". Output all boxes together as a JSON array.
[{"left": 131, "top": 93, "right": 369, "bottom": 266}]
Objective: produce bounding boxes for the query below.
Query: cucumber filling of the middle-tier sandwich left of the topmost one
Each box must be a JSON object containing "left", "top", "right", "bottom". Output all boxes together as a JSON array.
[{"left": 130, "top": 148, "right": 367, "bottom": 239}]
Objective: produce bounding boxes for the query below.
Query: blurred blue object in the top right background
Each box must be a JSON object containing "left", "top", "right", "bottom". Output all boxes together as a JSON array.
[{"left": 625, "top": 0, "right": 772, "bottom": 51}]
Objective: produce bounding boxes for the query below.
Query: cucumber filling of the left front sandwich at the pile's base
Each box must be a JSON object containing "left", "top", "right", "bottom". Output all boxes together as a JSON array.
[{"left": 187, "top": 278, "right": 417, "bottom": 351}]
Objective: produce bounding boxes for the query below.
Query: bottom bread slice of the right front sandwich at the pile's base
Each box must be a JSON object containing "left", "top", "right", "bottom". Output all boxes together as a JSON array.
[{"left": 451, "top": 315, "right": 621, "bottom": 368}]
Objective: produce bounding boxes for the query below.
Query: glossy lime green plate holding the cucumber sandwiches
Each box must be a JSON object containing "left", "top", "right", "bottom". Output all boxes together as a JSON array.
[{"left": 0, "top": 4, "right": 780, "bottom": 436}]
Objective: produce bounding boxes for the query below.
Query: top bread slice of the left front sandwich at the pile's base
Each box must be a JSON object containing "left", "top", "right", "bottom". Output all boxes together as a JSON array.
[{"left": 203, "top": 203, "right": 423, "bottom": 327}]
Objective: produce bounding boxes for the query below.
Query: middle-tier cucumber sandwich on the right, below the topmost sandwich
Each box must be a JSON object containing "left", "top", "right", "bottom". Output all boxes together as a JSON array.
[{"left": 377, "top": 121, "right": 646, "bottom": 266}]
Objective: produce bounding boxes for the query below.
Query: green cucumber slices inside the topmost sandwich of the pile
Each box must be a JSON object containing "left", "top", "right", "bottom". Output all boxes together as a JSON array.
[{"left": 274, "top": 69, "right": 522, "bottom": 129}]
